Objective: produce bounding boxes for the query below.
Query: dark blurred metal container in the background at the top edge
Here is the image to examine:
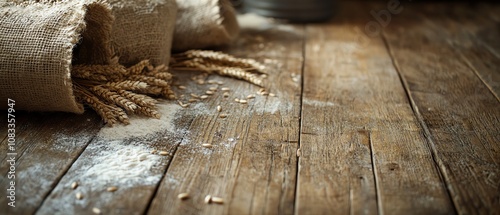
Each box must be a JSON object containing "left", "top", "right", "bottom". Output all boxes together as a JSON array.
[{"left": 243, "top": 0, "right": 335, "bottom": 22}]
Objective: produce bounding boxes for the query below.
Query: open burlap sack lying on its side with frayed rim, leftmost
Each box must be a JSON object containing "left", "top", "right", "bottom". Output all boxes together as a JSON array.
[{"left": 0, "top": 0, "right": 112, "bottom": 113}]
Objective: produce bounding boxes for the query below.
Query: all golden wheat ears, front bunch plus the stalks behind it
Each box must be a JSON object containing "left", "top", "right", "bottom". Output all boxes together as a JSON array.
[{"left": 71, "top": 50, "right": 266, "bottom": 126}]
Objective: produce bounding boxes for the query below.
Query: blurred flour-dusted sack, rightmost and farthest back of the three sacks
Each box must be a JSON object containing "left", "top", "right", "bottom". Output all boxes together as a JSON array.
[{"left": 172, "top": 0, "right": 239, "bottom": 51}]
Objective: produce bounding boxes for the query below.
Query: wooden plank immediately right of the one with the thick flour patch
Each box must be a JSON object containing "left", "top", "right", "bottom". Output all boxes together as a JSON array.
[{"left": 149, "top": 19, "right": 303, "bottom": 214}]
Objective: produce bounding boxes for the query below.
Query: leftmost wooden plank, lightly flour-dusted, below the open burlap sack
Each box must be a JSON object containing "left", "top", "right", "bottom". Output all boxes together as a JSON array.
[{"left": 0, "top": 112, "right": 102, "bottom": 214}]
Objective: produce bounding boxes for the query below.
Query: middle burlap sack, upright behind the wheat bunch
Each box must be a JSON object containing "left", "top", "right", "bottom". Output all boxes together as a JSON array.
[{"left": 108, "top": 0, "right": 177, "bottom": 65}]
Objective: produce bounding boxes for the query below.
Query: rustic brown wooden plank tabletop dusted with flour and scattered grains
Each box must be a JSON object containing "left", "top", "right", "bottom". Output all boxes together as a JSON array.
[{"left": 0, "top": 1, "right": 500, "bottom": 214}]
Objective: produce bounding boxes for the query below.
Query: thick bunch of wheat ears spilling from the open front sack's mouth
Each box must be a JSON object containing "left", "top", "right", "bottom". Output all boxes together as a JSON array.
[{"left": 71, "top": 60, "right": 175, "bottom": 125}]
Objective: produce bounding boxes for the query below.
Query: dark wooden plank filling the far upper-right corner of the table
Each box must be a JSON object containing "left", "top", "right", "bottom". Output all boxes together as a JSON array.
[{"left": 419, "top": 4, "right": 500, "bottom": 100}]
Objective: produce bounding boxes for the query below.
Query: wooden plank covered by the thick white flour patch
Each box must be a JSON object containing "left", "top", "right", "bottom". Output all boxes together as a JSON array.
[{"left": 37, "top": 101, "right": 190, "bottom": 214}]
